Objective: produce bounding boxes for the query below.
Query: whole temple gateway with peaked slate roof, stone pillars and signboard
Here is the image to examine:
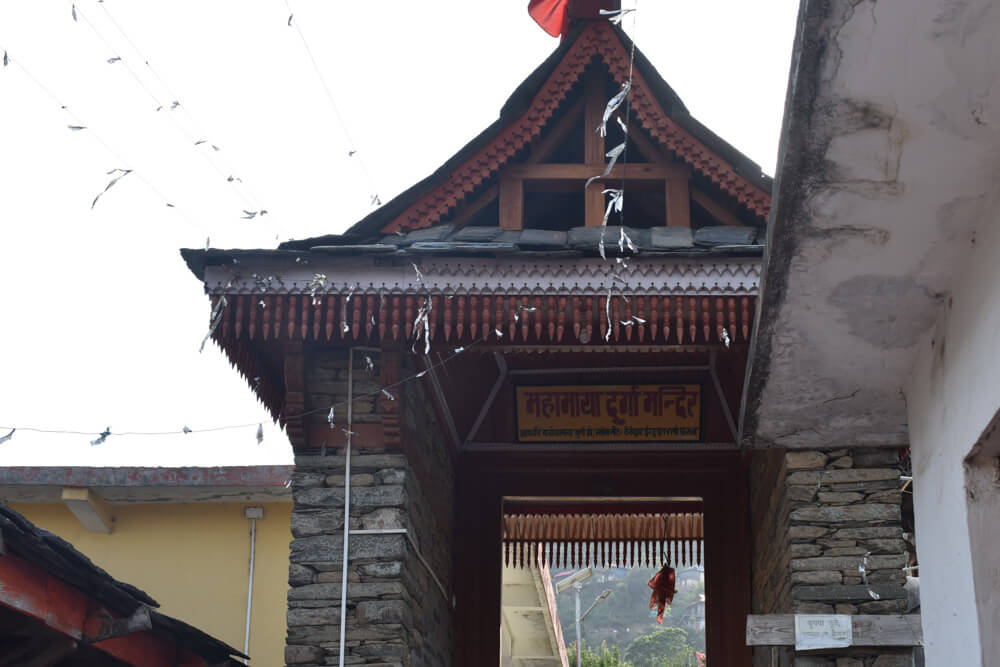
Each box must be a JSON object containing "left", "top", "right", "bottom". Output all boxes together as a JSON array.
[{"left": 183, "top": 0, "right": 920, "bottom": 667}]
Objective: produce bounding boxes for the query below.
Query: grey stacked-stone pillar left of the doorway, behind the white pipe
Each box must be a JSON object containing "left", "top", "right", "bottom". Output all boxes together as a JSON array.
[{"left": 285, "top": 351, "right": 454, "bottom": 667}]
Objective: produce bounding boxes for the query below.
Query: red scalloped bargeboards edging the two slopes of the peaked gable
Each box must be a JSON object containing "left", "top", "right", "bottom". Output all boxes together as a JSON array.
[{"left": 368, "top": 21, "right": 771, "bottom": 235}]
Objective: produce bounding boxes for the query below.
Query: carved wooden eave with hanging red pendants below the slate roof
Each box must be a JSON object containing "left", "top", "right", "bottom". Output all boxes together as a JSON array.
[{"left": 197, "top": 251, "right": 760, "bottom": 437}]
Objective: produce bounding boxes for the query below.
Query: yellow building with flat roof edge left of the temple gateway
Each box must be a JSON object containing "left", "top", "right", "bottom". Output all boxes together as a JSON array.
[{"left": 0, "top": 466, "right": 292, "bottom": 666}]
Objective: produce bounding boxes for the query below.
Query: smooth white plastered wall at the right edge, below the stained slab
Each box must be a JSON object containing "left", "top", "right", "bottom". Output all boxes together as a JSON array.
[{"left": 906, "top": 190, "right": 1000, "bottom": 666}]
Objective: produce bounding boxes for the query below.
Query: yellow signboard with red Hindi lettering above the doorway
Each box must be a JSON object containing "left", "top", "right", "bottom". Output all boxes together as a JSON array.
[{"left": 517, "top": 384, "right": 701, "bottom": 442}]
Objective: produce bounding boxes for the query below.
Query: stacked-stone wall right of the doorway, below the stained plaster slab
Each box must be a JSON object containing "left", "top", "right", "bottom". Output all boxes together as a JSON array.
[{"left": 751, "top": 449, "right": 913, "bottom": 667}]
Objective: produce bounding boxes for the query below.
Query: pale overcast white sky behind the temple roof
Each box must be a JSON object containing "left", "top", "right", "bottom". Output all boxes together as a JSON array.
[{"left": 0, "top": 0, "right": 798, "bottom": 466}]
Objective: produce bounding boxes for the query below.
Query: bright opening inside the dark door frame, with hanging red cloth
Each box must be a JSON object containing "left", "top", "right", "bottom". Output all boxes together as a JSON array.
[{"left": 501, "top": 498, "right": 707, "bottom": 667}]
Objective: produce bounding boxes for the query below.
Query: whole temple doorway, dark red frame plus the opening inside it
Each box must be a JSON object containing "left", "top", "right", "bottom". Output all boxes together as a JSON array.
[{"left": 454, "top": 450, "right": 750, "bottom": 667}]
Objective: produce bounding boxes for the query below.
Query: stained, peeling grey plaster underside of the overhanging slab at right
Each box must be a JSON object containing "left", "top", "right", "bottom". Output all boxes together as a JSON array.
[{"left": 742, "top": 0, "right": 1000, "bottom": 447}]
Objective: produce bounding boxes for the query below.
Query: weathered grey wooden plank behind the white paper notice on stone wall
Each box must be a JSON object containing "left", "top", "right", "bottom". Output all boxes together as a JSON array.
[{"left": 747, "top": 614, "right": 923, "bottom": 646}]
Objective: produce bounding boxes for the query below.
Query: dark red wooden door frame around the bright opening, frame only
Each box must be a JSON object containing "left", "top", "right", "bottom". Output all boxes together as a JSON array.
[{"left": 454, "top": 451, "right": 751, "bottom": 667}]
